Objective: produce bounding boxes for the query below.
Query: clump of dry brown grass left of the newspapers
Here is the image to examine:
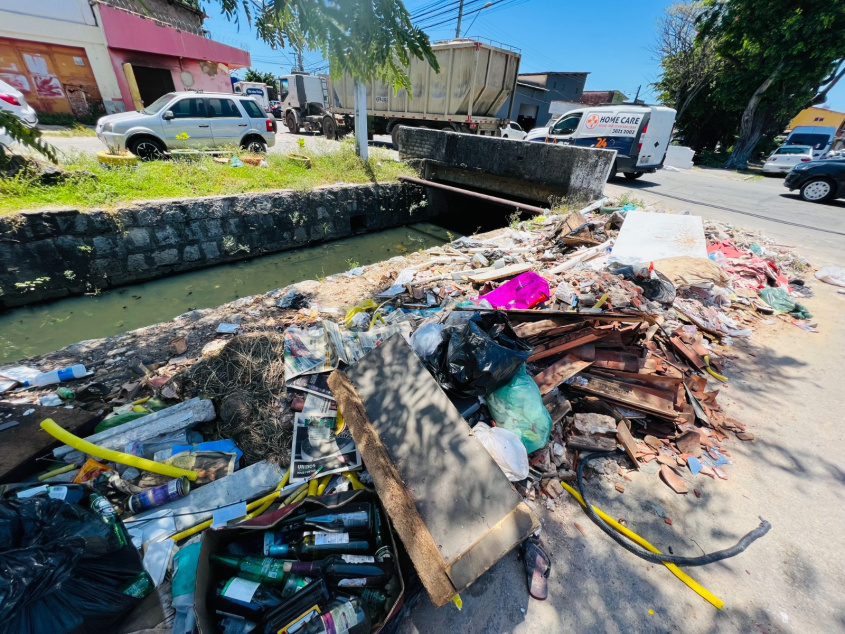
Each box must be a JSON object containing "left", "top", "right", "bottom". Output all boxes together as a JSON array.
[{"left": 173, "top": 333, "right": 293, "bottom": 467}]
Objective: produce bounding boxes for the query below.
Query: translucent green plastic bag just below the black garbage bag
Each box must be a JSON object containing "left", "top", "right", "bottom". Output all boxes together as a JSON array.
[{"left": 487, "top": 363, "right": 552, "bottom": 453}]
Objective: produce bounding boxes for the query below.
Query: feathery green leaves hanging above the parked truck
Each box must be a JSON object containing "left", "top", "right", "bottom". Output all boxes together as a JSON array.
[{"left": 212, "top": 0, "right": 439, "bottom": 89}]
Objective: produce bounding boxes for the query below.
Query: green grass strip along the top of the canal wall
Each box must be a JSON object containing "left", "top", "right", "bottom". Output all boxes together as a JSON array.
[{"left": 0, "top": 143, "right": 416, "bottom": 215}]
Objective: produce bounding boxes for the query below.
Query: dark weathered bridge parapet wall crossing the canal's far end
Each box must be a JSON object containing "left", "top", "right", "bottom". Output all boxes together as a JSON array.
[{"left": 399, "top": 126, "right": 616, "bottom": 202}]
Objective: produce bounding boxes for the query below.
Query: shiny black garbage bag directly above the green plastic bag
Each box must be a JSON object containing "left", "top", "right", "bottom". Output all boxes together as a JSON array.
[{"left": 428, "top": 310, "right": 532, "bottom": 396}]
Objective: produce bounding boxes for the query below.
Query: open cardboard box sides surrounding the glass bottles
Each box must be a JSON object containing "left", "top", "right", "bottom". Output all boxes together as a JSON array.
[{"left": 194, "top": 490, "right": 405, "bottom": 634}]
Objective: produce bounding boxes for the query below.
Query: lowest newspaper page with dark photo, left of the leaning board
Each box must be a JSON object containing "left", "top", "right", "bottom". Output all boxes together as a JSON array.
[{"left": 290, "top": 408, "right": 361, "bottom": 482}]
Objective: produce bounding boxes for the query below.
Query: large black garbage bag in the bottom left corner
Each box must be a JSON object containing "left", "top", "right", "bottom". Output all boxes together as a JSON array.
[{"left": 0, "top": 496, "right": 143, "bottom": 634}]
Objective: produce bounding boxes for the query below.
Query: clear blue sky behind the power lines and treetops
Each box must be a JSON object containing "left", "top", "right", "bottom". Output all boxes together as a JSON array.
[{"left": 205, "top": 0, "right": 845, "bottom": 111}]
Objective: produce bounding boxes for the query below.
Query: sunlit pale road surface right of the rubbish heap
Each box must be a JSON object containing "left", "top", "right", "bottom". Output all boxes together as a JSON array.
[{"left": 399, "top": 170, "right": 845, "bottom": 634}]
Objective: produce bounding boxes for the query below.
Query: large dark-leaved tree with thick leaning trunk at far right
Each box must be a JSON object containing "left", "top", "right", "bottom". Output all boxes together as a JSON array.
[{"left": 696, "top": 0, "right": 845, "bottom": 169}]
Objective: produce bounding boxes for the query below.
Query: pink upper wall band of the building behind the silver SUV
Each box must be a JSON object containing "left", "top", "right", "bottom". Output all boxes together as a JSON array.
[{"left": 97, "top": 4, "right": 250, "bottom": 68}]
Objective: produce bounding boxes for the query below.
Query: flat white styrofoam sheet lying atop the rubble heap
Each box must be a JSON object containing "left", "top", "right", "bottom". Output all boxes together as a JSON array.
[{"left": 609, "top": 211, "right": 707, "bottom": 265}]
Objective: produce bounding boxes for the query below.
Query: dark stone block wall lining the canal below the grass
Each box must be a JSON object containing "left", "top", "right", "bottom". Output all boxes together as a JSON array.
[{"left": 0, "top": 183, "right": 432, "bottom": 307}]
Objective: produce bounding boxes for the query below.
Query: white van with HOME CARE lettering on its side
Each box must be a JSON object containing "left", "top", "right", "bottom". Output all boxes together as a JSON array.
[{"left": 525, "top": 104, "right": 675, "bottom": 179}]
